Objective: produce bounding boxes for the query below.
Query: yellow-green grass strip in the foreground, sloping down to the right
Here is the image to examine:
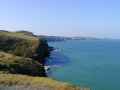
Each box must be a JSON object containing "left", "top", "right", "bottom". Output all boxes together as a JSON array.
[{"left": 0, "top": 74, "right": 79, "bottom": 90}]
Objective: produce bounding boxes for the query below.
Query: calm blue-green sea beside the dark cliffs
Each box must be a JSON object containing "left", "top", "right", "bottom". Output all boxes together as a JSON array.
[{"left": 46, "top": 40, "right": 120, "bottom": 90}]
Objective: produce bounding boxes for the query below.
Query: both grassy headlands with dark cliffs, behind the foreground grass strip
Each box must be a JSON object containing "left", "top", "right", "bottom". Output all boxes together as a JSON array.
[{"left": 0, "top": 32, "right": 49, "bottom": 76}]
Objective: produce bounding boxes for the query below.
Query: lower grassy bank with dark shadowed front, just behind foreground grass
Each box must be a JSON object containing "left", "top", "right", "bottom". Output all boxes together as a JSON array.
[{"left": 0, "top": 52, "right": 45, "bottom": 76}]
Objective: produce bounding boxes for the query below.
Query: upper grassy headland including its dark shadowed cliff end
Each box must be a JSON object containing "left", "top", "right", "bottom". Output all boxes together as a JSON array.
[{"left": 0, "top": 32, "right": 49, "bottom": 59}]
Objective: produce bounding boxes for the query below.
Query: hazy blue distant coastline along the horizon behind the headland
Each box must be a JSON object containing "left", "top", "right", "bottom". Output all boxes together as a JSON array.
[{"left": 0, "top": 30, "right": 112, "bottom": 42}]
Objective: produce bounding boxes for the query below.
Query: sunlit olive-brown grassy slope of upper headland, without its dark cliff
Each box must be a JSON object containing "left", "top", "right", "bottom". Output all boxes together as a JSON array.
[{"left": 0, "top": 32, "right": 40, "bottom": 57}]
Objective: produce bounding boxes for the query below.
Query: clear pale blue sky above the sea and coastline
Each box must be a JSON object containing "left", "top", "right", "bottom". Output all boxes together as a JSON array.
[{"left": 0, "top": 0, "right": 120, "bottom": 38}]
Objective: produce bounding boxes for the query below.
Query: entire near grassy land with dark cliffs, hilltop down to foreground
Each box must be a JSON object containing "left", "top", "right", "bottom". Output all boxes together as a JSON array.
[{"left": 0, "top": 31, "right": 80, "bottom": 90}]
